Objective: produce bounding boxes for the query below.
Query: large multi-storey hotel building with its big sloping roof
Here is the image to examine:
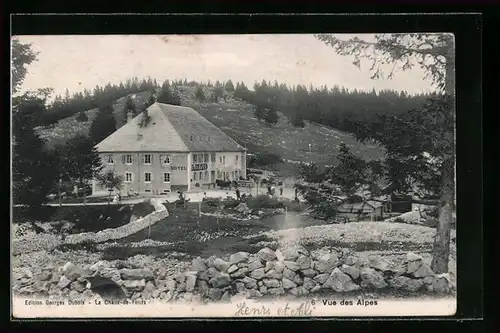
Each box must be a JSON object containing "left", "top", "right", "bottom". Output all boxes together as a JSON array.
[{"left": 92, "top": 103, "right": 246, "bottom": 195}]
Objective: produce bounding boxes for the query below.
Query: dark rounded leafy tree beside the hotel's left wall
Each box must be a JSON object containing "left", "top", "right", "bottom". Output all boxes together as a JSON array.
[{"left": 55, "top": 135, "right": 102, "bottom": 187}]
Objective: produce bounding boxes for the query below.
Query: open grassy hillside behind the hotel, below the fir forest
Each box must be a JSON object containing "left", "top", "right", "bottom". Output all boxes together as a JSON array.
[{"left": 37, "top": 86, "right": 383, "bottom": 164}]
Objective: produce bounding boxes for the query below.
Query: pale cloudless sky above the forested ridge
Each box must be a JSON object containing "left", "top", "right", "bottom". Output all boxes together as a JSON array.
[{"left": 12, "top": 34, "right": 433, "bottom": 95}]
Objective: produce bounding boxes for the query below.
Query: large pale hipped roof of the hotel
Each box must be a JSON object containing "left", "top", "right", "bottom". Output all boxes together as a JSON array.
[{"left": 95, "top": 103, "right": 245, "bottom": 152}]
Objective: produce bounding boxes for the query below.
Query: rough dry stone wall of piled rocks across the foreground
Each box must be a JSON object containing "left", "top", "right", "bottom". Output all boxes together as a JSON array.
[{"left": 15, "top": 246, "right": 454, "bottom": 302}]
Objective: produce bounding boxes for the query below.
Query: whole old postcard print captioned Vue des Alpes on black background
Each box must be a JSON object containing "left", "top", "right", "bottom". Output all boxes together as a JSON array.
[{"left": 10, "top": 32, "right": 460, "bottom": 318}]
